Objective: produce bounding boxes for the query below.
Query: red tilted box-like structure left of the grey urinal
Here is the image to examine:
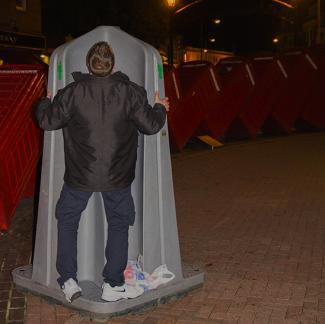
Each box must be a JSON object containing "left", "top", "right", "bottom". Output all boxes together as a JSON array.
[{"left": 0, "top": 65, "right": 45, "bottom": 230}]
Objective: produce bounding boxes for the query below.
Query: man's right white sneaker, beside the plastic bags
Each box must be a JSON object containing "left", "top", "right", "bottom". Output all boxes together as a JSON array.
[{"left": 102, "top": 282, "right": 144, "bottom": 301}]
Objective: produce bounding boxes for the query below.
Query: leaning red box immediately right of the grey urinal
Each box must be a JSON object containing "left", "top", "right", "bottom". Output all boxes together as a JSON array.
[{"left": 165, "top": 62, "right": 220, "bottom": 150}]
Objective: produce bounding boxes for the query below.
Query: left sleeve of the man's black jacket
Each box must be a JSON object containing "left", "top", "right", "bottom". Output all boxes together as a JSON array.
[{"left": 35, "top": 87, "right": 72, "bottom": 131}]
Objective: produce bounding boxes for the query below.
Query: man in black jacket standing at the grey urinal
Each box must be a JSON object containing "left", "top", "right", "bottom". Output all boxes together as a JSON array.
[{"left": 36, "top": 42, "right": 169, "bottom": 302}]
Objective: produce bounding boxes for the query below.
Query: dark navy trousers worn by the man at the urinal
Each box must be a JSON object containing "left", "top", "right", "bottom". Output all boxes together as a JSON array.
[{"left": 56, "top": 184, "right": 135, "bottom": 286}]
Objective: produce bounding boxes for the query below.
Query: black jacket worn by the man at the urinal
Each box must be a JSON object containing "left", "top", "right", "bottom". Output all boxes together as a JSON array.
[{"left": 36, "top": 72, "right": 166, "bottom": 191}]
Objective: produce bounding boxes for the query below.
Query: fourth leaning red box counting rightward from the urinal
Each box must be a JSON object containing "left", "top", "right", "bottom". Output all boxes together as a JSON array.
[{"left": 262, "top": 51, "right": 317, "bottom": 134}]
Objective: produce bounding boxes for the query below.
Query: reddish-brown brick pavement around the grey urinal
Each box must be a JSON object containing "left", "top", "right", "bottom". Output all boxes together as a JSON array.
[{"left": 0, "top": 133, "right": 325, "bottom": 324}]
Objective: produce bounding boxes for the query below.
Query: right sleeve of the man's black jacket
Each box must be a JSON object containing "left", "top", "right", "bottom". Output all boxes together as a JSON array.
[{"left": 130, "top": 87, "right": 166, "bottom": 135}]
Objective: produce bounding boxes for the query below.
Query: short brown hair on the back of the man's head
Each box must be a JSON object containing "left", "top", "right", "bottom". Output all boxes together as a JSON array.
[{"left": 86, "top": 42, "right": 115, "bottom": 77}]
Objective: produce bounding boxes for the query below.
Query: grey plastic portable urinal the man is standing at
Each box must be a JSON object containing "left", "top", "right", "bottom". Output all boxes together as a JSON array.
[{"left": 13, "top": 27, "right": 204, "bottom": 317}]
